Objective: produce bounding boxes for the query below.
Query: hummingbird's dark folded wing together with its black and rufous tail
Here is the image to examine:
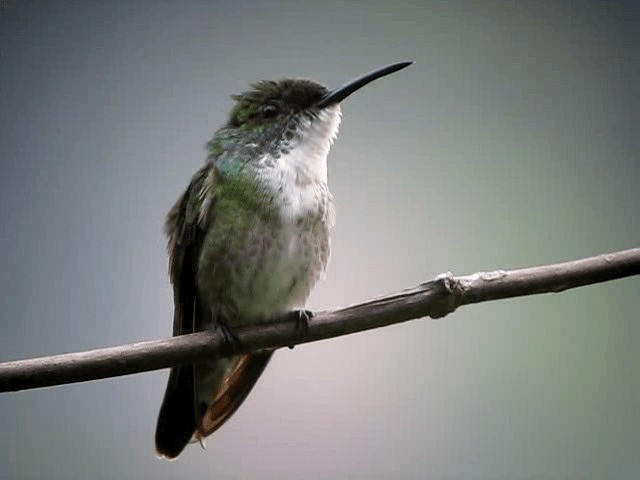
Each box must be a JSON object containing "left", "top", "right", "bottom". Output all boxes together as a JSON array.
[{"left": 156, "top": 158, "right": 273, "bottom": 458}]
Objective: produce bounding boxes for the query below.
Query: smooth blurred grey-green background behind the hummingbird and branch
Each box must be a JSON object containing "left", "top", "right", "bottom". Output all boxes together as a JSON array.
[{"left": 0, "top": 0, "right": 640, "bottom": 479}]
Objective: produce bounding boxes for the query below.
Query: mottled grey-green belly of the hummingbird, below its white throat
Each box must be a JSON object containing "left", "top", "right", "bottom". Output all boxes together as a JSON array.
[{"left": 197, "top": 196, "right": 330, "bottom": 327}]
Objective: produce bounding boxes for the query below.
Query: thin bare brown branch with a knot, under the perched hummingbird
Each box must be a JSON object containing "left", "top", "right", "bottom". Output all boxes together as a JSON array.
[{"left": 0, "top": 248, "right": 640, "bottom": 392}]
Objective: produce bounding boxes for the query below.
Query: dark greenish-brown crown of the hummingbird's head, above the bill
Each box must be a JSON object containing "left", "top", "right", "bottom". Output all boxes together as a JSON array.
[{"left": 227, "top": 78, "right": 329, "bottom": 128}]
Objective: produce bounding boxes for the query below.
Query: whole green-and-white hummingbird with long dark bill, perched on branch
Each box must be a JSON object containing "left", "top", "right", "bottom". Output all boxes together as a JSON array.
[{"left": 155, "top": 62, "right": 413, "bottom": 459}]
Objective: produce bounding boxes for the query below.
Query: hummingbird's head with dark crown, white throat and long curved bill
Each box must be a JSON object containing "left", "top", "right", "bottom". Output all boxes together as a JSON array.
[{"left": 210, "top": 62, "right": 413, "bottom": 186}]
